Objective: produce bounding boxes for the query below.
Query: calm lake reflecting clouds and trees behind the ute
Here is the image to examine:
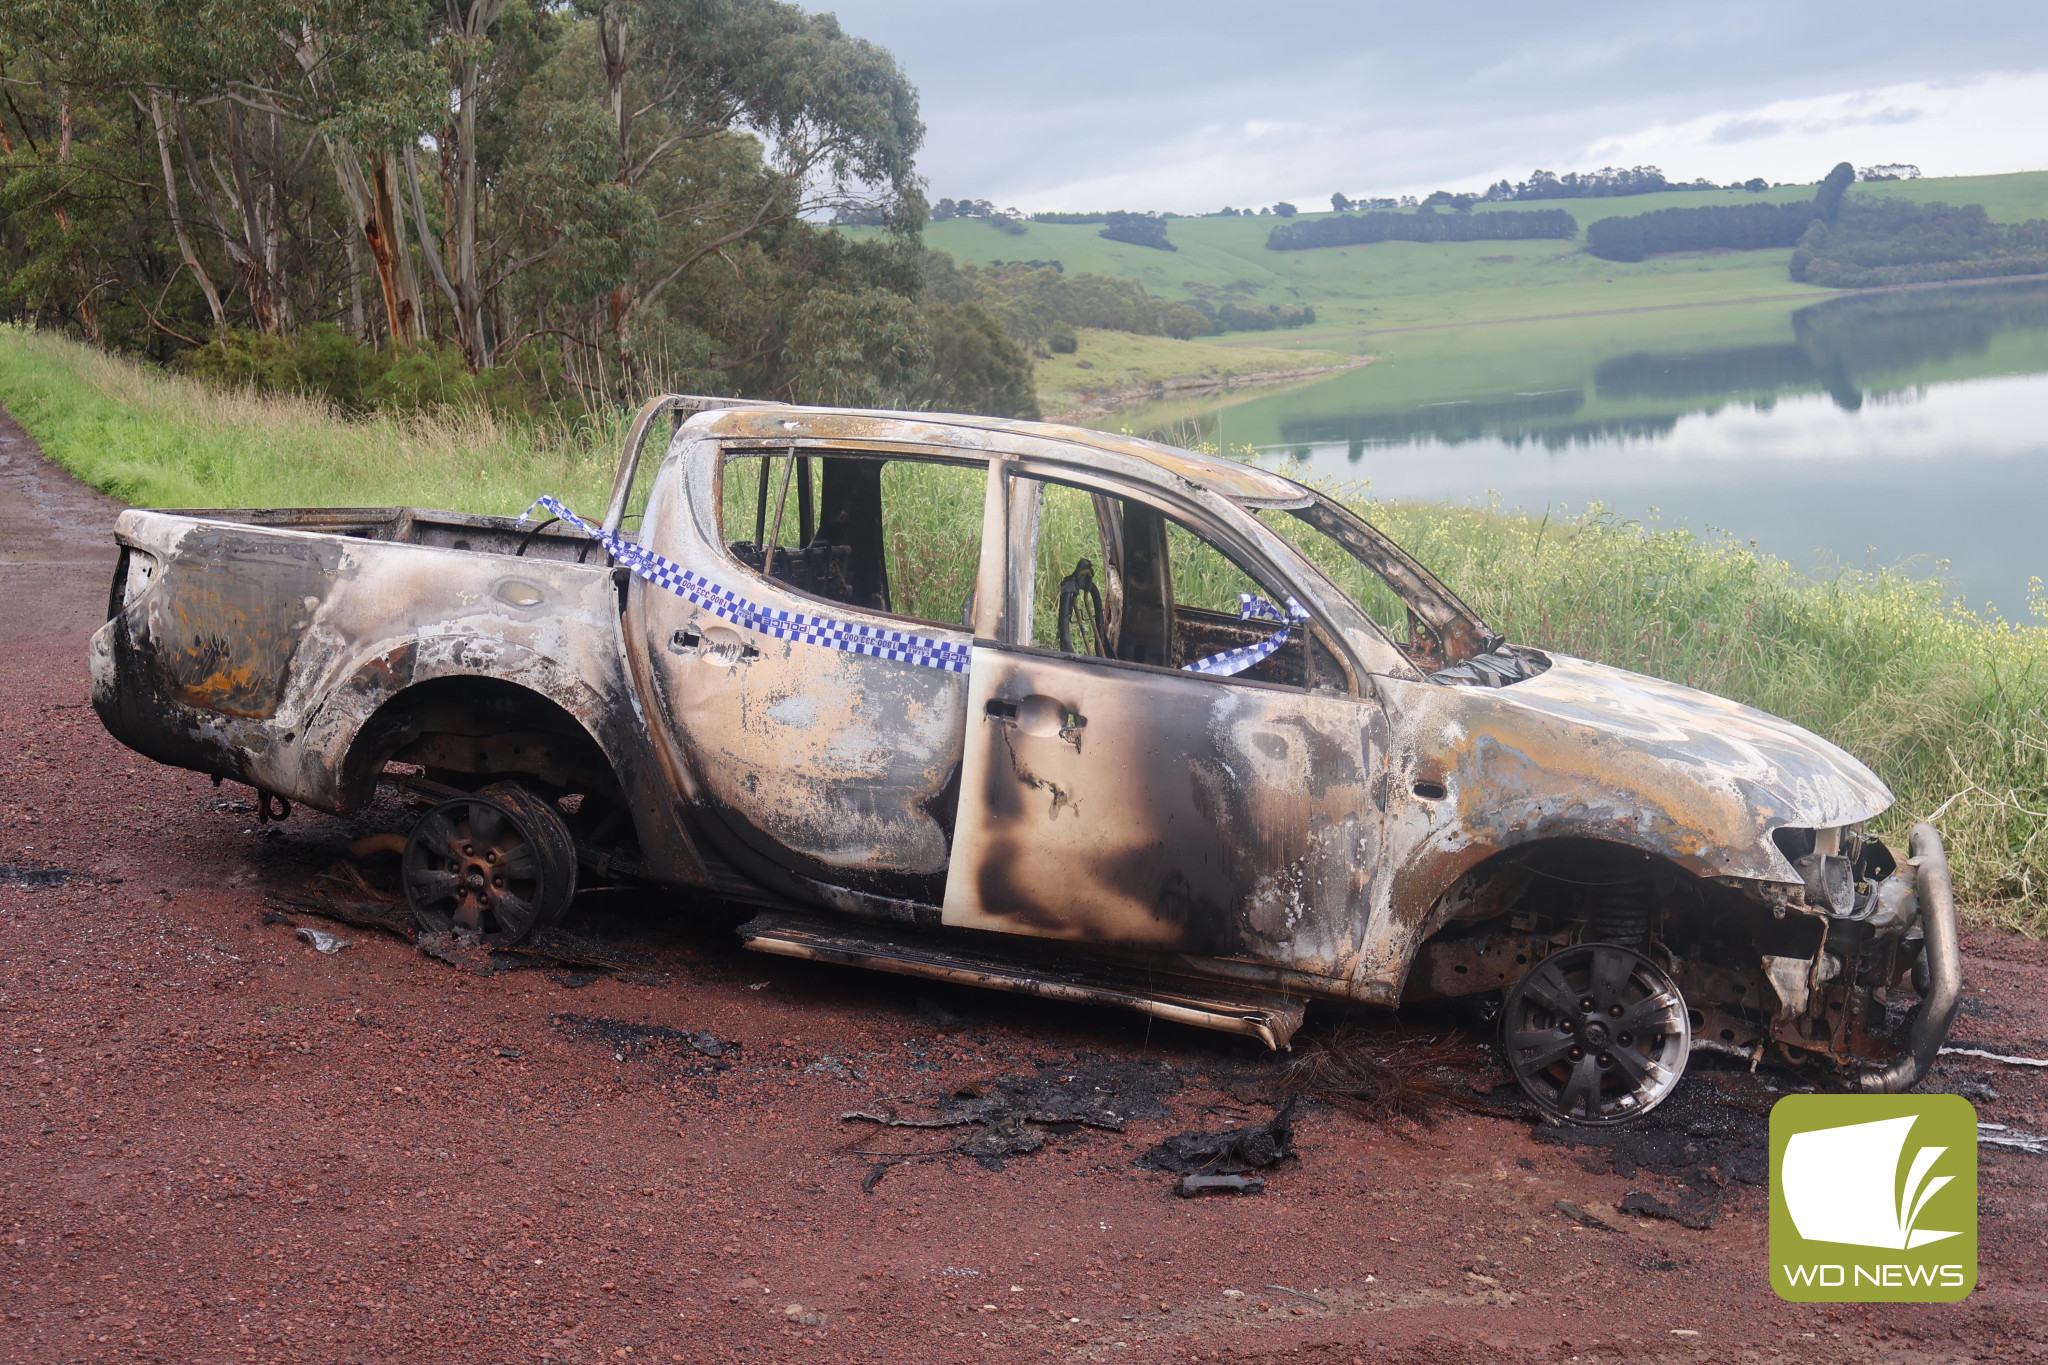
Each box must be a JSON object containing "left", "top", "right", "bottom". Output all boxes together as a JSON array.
[{"left": 1102, "top": 284, "right": 2048, "bottom": 620}]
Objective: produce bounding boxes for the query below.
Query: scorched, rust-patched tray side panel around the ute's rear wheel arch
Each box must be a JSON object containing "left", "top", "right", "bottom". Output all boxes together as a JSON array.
[{"left": 90, "top": 510, "right": 705, "bottom": 880}]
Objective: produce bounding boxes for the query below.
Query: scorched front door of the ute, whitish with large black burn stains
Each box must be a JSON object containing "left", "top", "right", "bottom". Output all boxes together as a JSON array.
[{"left": 944, "top": 481, "right": 1386, "bottom": 978}]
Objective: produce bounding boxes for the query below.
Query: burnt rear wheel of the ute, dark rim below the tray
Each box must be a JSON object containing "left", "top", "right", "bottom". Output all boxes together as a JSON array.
[{"left": 403, "top": 782, "right": 575, "bottom": 945}]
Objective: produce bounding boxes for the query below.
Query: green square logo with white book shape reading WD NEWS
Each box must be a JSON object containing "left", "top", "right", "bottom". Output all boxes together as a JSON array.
[{"left": 1772, "top": 1095, "right": 1976, "bottom": 1304}]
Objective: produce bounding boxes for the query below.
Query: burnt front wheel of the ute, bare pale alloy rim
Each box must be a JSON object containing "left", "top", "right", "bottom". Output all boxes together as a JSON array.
[{"left": 1501, "top": 943, "right": 1692, "bottom": 1126}]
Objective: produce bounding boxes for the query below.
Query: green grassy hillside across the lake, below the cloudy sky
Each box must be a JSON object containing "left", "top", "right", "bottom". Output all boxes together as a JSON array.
[{"left": 850, "top": 172, "right": 2048, "bottom": 354}]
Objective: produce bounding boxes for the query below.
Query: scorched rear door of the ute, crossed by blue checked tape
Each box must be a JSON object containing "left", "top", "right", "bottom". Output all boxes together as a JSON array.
[{"left": 643, "top": 448, "right": 987, "bottom": 902}]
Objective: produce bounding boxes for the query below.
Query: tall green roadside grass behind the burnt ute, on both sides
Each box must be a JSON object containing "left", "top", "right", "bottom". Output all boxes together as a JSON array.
[{"left": 0, "top": 329, "right": 2048, "bottom": 933}]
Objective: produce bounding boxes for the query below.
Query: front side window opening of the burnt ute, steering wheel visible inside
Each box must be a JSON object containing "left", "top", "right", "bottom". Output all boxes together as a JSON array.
[{"left": 1012, "top": 479, "right": 1346, "bottom": 690}]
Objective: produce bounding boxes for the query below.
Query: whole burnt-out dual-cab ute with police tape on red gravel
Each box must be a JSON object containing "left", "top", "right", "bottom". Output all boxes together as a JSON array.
[{"left": 92, "top": 397, "right": 1960, "bottom": 1124}]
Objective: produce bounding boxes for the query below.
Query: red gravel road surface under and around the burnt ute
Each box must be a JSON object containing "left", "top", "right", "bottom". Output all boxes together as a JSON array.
[{"left": 0, "top": 417, "right": 2048, "bottom": 1365}]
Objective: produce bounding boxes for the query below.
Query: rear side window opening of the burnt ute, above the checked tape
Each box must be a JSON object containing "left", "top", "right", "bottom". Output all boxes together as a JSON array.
[{"left": 721, "top": 448, "right": 987, "bottom": 626}]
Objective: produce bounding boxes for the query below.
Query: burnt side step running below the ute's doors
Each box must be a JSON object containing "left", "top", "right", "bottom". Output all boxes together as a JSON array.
[{"left": 739, "top": 911, "right": 1307, "bottom": 1048}]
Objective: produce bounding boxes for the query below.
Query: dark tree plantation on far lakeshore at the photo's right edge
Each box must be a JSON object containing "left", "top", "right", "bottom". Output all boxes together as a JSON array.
[{"left": 1792, "top": 201, "right": 2048, "bottom": 289}]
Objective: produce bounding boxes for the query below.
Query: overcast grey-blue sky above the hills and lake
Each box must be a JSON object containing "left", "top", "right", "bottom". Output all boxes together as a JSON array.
[{"left": 809, "top": 0, "right": 2048, "bottom": 213}]
